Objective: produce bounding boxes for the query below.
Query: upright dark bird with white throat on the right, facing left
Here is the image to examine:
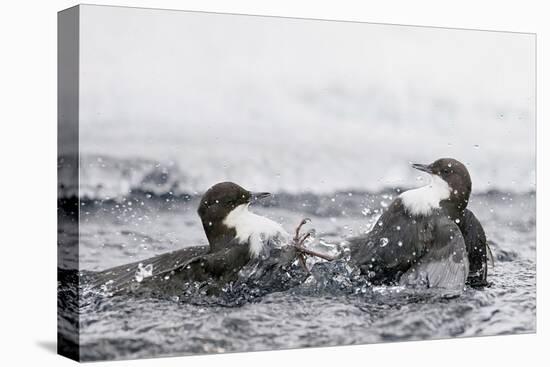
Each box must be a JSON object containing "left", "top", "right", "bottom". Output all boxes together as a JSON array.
[{"left": 347, "top": 158, "right": 488, "bottom": 292}]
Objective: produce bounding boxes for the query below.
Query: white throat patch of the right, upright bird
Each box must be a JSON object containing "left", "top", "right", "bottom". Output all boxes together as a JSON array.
[{"left": 399, "top": 175, "right": 451, "bottom": 215}]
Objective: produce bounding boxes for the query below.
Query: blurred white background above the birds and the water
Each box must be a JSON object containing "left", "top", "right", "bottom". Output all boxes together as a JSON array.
[{"left": 80, "top": 6, "right": 535, "bottom": 196}]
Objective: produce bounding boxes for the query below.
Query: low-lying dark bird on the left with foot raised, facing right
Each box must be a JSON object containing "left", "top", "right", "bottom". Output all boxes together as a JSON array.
[{"left": 88, "top": 182, "right": 323, "bottom": 295}]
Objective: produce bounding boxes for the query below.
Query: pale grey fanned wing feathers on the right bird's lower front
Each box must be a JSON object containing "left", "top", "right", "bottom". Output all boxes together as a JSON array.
[{"left": 400, "top": 217, "right": 469, "bottom": 292}]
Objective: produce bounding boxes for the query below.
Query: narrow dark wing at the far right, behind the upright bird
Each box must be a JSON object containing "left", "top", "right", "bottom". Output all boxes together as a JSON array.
[{"left": 460, "top": 209, "right": 490, "bottom": 287}]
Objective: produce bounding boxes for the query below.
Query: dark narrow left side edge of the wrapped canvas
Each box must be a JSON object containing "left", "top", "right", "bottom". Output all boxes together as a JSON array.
[{"left": 57, "top": 5, "right": 80, "bottom": 361}]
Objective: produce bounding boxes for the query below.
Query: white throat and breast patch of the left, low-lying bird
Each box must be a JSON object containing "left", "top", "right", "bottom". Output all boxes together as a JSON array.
[{"left": 223, "top": 204, "right": 289, "bottom": 257}]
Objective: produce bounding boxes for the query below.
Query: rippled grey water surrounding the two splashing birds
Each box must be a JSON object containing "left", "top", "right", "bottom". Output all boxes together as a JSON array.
[{"left": 61, "top": 191, "right": 536, "bottom": 360}]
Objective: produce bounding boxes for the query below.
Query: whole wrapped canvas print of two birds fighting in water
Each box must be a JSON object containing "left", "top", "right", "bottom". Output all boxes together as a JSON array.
[{"left": 58, "top": 5, "right": 536, "bottom": 361}]
